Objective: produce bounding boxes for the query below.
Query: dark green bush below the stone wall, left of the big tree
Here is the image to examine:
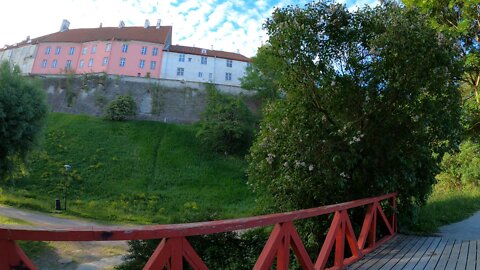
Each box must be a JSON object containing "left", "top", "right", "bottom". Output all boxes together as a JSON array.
[{"left": 197, "top": 84, "right": 254, "bottom": 156}]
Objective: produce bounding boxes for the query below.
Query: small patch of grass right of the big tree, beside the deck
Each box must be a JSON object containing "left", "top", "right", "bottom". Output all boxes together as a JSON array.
[{"left": 409, "top": 187, "right": 480, "bottom": 234}]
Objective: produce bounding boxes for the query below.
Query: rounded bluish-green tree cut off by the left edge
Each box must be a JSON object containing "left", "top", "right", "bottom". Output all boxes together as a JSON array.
[{"left": 0, "top": 62, "right": 48, "bottom": 179}]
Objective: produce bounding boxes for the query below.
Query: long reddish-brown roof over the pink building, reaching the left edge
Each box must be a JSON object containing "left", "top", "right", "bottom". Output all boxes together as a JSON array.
[{"left": 0, "top": 26, "right": 172, "bottom": 49}]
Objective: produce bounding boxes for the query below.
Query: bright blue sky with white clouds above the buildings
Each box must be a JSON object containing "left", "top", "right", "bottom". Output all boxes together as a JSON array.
[{"left": 0, "top": 0, "right": 378, "bottom": 57}]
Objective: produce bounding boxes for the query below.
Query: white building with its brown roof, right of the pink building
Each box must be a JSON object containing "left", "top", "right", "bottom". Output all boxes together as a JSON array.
[{"left": 160, "top": 45, "right": 251, "bottom": 87}]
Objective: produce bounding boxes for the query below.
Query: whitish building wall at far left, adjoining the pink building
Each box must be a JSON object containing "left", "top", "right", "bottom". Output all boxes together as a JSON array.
[{"left": 0, "top": 45, "right": 37, "bottom": 74}]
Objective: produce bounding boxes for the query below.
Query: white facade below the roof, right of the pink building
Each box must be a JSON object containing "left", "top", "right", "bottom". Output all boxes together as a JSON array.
[{"left": 161, "top": 51, "right": 248, "bottom": 86}]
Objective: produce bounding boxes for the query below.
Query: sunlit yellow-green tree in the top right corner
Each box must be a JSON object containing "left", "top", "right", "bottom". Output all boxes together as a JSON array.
[{"left": 404, "top": 0, "right": 480, "bottom": 135}]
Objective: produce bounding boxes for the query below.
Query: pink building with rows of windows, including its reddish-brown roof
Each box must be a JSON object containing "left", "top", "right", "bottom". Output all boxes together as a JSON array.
[{"left": 31, "top": 21, "right": 172, "bottom": 78}]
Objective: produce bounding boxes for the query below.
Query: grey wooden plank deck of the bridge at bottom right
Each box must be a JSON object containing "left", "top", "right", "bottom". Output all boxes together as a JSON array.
[{"left": 347, "top": 235, "right": 480, "bottom": 270}]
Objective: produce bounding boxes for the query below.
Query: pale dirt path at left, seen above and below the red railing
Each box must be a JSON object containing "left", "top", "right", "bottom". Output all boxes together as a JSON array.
[{"left": 0, "top": 205, "right": 127, "bottom": 270}]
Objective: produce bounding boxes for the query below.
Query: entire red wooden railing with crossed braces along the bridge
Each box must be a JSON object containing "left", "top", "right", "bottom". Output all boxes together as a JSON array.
[{"left": 0, "top": 193, "right": 397, "bottom": 270}]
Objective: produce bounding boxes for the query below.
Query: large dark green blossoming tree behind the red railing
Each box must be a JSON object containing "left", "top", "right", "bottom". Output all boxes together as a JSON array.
[{"left": 248, "top": 1, "right": 460, "bottom": 234}]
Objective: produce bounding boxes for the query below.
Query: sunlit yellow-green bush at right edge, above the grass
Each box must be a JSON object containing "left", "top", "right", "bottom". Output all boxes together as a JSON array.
[{"left": 437, "top": 141, "right": 480, "bottom": 189}]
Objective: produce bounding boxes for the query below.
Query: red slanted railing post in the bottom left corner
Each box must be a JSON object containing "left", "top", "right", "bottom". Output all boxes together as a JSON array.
[{"left": 0, "top": 240, "right": 37, "bottom": 270}]
